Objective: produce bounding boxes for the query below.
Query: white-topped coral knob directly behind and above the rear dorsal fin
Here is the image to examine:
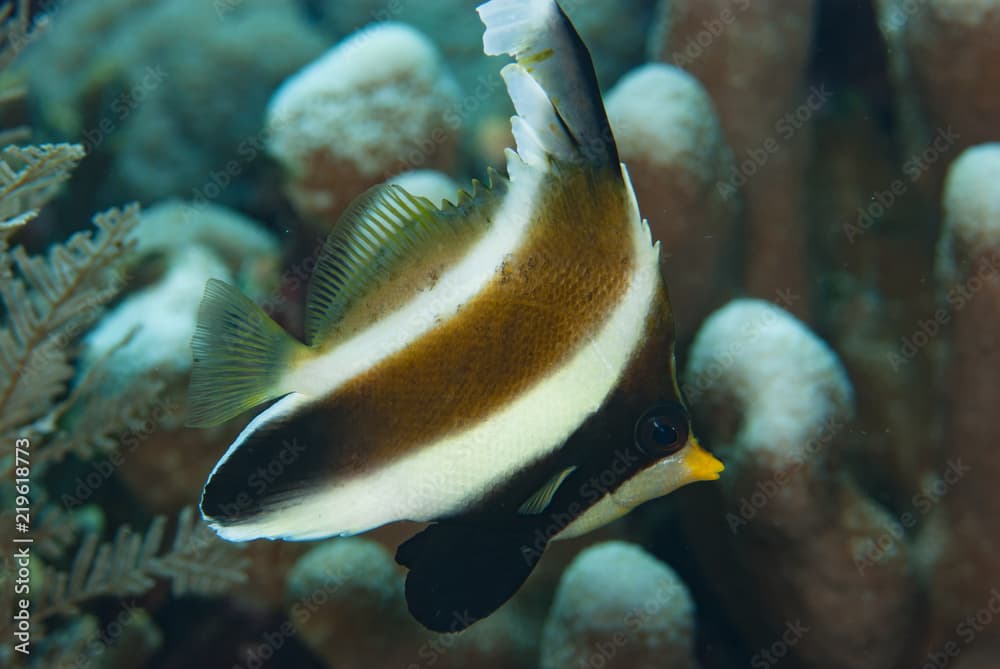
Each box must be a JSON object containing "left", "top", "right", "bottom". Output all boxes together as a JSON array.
[{"left": 267, "top": 23, "right": 458, "bottom": 224}]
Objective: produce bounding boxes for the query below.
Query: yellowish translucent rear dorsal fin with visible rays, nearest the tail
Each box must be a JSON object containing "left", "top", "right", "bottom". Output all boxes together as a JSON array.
[{"left": 305, "top": 170, "right": 507, "bottom": 346}]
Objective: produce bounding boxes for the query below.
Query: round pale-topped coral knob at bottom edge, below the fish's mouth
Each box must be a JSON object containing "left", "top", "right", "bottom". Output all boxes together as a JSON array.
[{"left": 540, "top": 541, "right": 697, "bottom": 669}]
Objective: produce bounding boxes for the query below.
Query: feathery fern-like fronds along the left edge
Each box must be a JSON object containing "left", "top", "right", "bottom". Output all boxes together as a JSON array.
[{"left": 0, "top": 2, "right": 250, "bottom": 667}]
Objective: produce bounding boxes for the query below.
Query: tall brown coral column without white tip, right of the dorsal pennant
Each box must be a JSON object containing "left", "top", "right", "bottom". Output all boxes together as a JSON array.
[{"left": 649, "top": 0, "right": 829, "bottom": 315}]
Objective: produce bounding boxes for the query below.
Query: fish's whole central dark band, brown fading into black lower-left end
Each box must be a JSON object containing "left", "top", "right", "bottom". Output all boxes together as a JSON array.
[{"left": 203, "top": 171, "right": 641, "bottom": 521}]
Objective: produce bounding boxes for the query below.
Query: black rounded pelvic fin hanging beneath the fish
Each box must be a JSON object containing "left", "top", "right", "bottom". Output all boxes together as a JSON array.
[{"left": 396, "top": 523, "right": 545, "bottom": 632}]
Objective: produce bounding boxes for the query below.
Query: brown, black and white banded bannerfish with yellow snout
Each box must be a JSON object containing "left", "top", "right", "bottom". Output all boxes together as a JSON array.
[{"left": 189, "top": 0, "right": 722, "bottom": 631}]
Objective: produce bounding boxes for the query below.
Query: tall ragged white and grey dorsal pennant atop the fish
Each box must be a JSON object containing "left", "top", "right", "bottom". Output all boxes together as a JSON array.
[{"left": 476, "top": 0, "right": 620, "bottom": 173}]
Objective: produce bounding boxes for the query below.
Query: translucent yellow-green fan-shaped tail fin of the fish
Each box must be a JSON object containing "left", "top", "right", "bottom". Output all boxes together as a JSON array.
[{"left": 188, "top": 279, "right": 304, "bottom": 427}]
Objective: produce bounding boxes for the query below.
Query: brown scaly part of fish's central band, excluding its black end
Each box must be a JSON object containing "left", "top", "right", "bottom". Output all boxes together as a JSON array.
[{"left": 316, "top": 170, "right": 632, "bottom": 464}]
